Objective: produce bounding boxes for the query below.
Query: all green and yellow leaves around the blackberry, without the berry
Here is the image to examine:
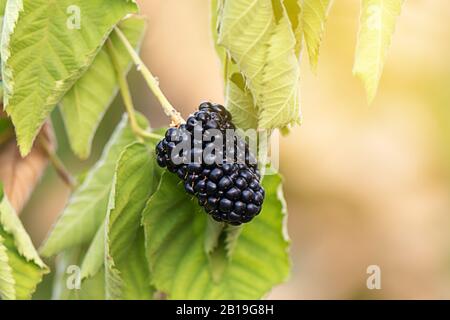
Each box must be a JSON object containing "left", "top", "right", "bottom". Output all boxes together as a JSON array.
[{"left": 0, "top": 0, "right": 403, "bottom": 299}]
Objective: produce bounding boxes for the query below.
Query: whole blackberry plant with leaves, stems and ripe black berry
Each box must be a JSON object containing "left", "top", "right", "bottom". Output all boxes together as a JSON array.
[{"left": 0, "top": 0, "right": 403, "bottom": 299}]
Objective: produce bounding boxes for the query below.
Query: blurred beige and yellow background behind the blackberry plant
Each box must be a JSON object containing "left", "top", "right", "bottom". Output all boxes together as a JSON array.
[{"left": 22, "top": 0, "right": 450, "bottom": 299}]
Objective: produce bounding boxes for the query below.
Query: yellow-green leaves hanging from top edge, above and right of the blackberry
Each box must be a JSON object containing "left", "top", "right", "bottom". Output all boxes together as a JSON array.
[{"left": 212, "top": 0, "right": 404, "bottom": 131}]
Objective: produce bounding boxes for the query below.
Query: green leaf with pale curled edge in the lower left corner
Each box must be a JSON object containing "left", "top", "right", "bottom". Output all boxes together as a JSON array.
[{"left": 0, "top": 185, "right": 49, "bottom": 300}]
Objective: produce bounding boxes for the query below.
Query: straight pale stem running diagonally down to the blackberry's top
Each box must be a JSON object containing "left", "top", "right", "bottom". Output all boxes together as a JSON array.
[{"left": 115, "top": 27, "right": 185, "bottom": 126}]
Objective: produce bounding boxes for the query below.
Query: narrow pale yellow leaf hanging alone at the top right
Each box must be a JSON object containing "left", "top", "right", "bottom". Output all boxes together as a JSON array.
[{"left": 353, "top": 0, "right": 404, "bottom": 102}]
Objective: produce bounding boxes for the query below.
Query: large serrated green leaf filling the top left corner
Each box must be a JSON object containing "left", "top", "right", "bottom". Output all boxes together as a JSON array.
[{"left": 1, "top": 0, "right": 137, "bottom": 156}]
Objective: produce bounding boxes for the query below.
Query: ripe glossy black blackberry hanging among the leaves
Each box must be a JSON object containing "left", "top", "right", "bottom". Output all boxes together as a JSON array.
[{"left": 156, "top": 102, "right": 264, "bottom": 225}]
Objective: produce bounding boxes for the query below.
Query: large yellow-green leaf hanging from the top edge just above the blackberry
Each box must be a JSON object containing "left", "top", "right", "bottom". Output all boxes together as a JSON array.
[{"left": 218, "top": 0, "right": 300, "bottom": 129}]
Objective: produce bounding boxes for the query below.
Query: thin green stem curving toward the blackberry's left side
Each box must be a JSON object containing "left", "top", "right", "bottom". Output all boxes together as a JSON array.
[{"left": 106, "top": 39, "right": 162, "bottom": 140}]
